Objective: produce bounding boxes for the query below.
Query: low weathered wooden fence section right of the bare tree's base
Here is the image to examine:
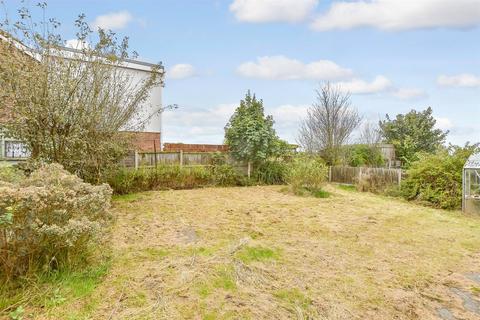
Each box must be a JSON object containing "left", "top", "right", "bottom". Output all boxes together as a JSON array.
[{"left": 329, "top": 166, "right": 402, "bottom": 185}]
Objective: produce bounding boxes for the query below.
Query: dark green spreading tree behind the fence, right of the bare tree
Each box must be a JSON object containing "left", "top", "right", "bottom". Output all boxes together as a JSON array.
[{"left": 379, "top": 107, "right": 448, "bottom": 167}]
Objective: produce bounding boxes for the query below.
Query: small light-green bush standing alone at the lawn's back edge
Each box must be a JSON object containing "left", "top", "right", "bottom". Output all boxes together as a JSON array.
[{"left": 287, "top": 156, "right": 328, "bottom": 194}]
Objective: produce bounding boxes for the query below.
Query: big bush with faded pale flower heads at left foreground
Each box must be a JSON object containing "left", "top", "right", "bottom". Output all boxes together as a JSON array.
[{"left": 0, "top": 164, "right": 112, "bottom": 279}]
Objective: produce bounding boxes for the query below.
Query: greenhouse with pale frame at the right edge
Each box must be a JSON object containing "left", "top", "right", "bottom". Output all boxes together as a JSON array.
[{"left": 462, "top": 153, "right": 480, "bottom": 214}]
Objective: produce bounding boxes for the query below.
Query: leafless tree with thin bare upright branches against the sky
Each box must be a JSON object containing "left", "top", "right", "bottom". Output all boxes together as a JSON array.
[{"left": 298, "top": 83, "right": 361, "bottom": 165}]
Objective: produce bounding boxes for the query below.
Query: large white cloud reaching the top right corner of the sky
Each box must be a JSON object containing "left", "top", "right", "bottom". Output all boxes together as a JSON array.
[{"left": 311, "top": 0, "right": 480, "bottom": 31}]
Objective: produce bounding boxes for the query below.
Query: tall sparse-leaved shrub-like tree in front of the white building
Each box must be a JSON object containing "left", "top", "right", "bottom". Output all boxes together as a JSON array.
[{"left": 0, "top": 4, "right": 163, "bottom": 182}]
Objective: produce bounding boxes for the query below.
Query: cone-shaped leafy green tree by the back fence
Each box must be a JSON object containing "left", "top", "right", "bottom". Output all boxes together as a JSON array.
[{"left": 225, "top": 91, "right": 286, "bottom": 177}]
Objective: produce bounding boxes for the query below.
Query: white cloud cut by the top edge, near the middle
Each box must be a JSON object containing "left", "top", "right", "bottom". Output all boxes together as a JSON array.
[{"left": 230, "top": 0, "right": 318, "bottom": 23}]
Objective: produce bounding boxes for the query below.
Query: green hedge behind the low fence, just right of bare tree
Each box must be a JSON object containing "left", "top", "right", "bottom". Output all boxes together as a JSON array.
[{"left": 345, "top": 144, "right": 385, "bottom": 167}]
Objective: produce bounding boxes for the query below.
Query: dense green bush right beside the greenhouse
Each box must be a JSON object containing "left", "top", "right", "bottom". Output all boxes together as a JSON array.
[{"left": 401, "top": 144, "right": 478, "bottom": 209}]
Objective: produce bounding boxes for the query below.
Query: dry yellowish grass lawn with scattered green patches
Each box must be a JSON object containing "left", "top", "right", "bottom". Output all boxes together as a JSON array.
[{"left": 4, "top": 186, "right": 480, "bottom": 319}]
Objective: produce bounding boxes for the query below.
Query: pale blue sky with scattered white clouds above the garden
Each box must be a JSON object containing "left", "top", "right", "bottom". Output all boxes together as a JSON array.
[{"left": 0, "top": 0, "right": 480, "bottom": 144}]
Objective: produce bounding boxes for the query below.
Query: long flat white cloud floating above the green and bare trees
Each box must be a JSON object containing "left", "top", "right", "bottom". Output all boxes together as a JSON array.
[{"left": 237, "top": 56, "right": 353, "bottom": 80}]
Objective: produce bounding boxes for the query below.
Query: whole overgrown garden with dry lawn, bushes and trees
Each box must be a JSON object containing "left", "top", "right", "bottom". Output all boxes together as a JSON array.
[{"left": 0, "top": 4, "right": 480, "bottom": 320}]
